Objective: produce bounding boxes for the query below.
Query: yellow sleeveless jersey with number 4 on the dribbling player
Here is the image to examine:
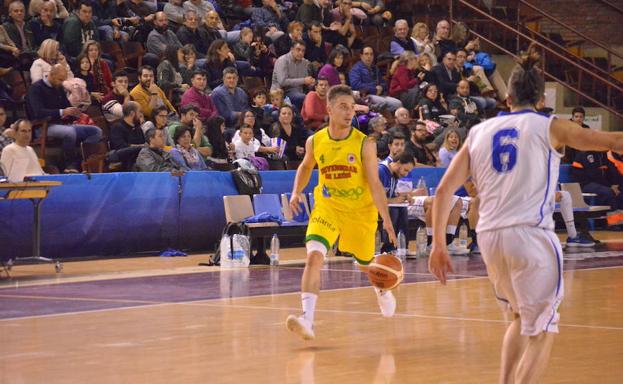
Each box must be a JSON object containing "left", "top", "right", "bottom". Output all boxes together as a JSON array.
[{"left": 313, "top": 127, "right": 374, "bottom": 211}]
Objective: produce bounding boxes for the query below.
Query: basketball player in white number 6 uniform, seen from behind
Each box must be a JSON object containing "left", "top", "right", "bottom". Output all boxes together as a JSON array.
[{"left": 429, "top": 47, "right": 623, "bottom": 383}]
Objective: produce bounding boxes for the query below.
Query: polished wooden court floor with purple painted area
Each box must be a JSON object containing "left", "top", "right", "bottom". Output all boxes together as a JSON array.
[{"left": 0, "top": 234, "right": 623, "bottom": 384}]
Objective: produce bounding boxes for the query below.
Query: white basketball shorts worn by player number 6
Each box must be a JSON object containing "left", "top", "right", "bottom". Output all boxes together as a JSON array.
[{"left": 478, "top": 226, "right": 564, "bottom": 336}]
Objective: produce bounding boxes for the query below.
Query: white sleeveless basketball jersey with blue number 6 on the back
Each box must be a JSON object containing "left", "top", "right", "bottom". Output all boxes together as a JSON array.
[{"left": 466, "top": 110, "right": 562, "bottom": 232}]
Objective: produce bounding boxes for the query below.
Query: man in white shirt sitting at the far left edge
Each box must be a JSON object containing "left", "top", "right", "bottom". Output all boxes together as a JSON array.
[{"left": 0, "top": 119, "right": 44, "bottom": 182}]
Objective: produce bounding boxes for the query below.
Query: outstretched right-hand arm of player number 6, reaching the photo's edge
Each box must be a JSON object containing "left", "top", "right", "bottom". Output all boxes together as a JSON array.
[{"left": 550, "top": 119, "right": 623, "bottom": 153}]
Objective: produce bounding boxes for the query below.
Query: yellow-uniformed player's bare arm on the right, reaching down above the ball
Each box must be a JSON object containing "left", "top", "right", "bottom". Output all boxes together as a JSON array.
[{"left": 361, "top": 139, "right": 398, "bottom": 244}]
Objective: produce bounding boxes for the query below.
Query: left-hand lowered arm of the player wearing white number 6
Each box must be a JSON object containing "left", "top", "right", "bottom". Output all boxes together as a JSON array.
[{"left": 428, "top": 144, "right": 470, "bottom": 284}]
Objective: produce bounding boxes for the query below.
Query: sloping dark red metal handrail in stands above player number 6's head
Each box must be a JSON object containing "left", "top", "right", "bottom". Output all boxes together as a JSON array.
[{"left": 450, "top": 0, "right": 623, "bottom": 119}]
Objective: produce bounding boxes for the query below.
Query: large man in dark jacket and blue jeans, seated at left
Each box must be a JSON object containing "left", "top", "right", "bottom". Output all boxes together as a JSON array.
[{"left": 28, "top": 64, "right": 102, "bottom": 172}]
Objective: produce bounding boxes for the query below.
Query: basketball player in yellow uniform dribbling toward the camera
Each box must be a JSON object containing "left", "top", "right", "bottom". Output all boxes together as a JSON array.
[{"left": 286, "top": 85, "right": 396, "bottom": 340}]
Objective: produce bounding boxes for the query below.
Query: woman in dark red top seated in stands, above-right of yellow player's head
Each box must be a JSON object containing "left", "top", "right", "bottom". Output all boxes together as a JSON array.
[{"left": 389, "top": 51, "right": 424, "bottom": 112}]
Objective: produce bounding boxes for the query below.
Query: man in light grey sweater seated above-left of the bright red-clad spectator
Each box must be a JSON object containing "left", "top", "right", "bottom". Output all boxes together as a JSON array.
[{"left": 271, "top": 40, "right": 316, "bottom": 111}]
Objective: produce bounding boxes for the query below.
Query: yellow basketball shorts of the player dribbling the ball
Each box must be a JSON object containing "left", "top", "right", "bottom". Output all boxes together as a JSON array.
[{"left": 305, "top": 203, "right": 378, "bottom": 265}]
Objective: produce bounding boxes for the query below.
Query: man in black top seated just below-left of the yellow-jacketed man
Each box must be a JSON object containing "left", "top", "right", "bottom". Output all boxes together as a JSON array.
[{"left": 108, "top": 101, "right": 145, "bottom": 171}]
